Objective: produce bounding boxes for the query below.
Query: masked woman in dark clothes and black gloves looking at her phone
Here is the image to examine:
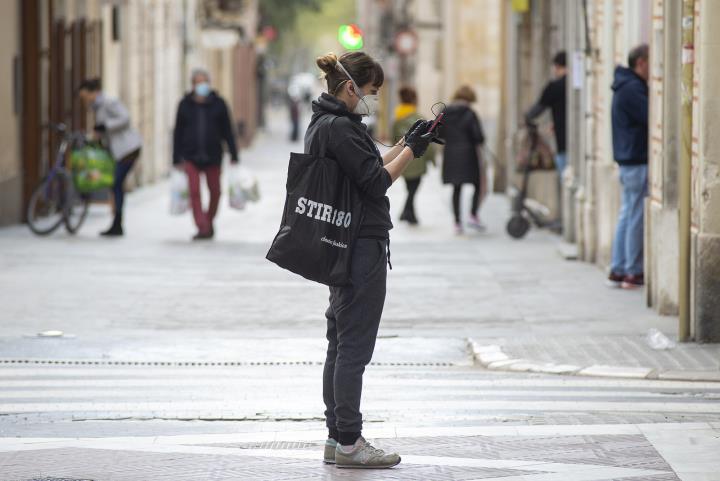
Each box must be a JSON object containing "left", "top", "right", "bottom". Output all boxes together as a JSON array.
[{"left": 305, "top": 52, "right": 429, "bottom": 468}]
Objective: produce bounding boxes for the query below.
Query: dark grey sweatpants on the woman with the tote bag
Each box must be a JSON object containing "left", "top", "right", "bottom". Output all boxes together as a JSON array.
[{"left": 323, "top": 239, "right": 387, "bottom": 432}]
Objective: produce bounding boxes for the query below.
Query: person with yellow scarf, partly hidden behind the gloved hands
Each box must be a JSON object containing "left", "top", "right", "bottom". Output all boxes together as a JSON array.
[{"left": 393, "top": 87, "right": 435, "bottom": 225}]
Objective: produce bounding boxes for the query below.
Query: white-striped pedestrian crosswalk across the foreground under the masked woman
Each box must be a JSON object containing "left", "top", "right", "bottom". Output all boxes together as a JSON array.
[{"left": 0, "top": 354, "right": 720, "bottom": 481}]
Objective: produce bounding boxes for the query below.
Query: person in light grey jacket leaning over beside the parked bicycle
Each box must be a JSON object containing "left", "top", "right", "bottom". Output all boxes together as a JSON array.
[{"left": 78, "top": 78, "right": 142, "bottom": 237}]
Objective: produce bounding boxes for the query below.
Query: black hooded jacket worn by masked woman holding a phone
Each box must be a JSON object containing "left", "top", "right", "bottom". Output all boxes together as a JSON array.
[{"left": 305, "top": 93, "right": 393, "bottom": 238}]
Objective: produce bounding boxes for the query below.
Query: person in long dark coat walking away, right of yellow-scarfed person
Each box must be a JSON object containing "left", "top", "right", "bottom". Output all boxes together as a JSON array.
[{"left": 442, "top": 86, "right": 485, "bottom": 234}]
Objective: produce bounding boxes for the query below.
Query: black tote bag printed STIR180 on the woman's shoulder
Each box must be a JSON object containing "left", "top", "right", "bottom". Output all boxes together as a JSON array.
[{"left": 266, "top": 116, "right": 363, "bottom": 286}]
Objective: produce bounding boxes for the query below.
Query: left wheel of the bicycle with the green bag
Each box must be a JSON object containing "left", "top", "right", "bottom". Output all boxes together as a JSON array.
[{"left": 27, "top": 172, "right": 67, "bottom": 235}]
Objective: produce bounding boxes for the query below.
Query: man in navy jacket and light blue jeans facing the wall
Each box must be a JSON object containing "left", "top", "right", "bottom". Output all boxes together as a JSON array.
[{"left": 607, "top": 45, "right": 650, "bottom": 289}]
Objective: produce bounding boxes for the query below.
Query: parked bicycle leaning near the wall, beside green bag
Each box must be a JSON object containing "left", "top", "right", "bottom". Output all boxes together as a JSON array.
[{"left": 27, "top": 123, "right": 90, "bottom": 235}]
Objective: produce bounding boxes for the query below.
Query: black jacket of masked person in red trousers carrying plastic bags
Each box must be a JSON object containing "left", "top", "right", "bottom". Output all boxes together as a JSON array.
[{"left": 173, "top": 91, "right": 238, "bottom": 166}]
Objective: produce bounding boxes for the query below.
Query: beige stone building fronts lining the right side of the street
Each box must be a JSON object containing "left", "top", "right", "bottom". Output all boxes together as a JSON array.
[{"left": 502, "top": 0, "right": 720, "bottom": 342}]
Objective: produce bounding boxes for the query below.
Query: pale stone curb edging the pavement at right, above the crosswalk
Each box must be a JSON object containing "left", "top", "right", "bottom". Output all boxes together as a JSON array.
[{"left": 467, "top": 338, "right": 720, "bottom": 382}]
